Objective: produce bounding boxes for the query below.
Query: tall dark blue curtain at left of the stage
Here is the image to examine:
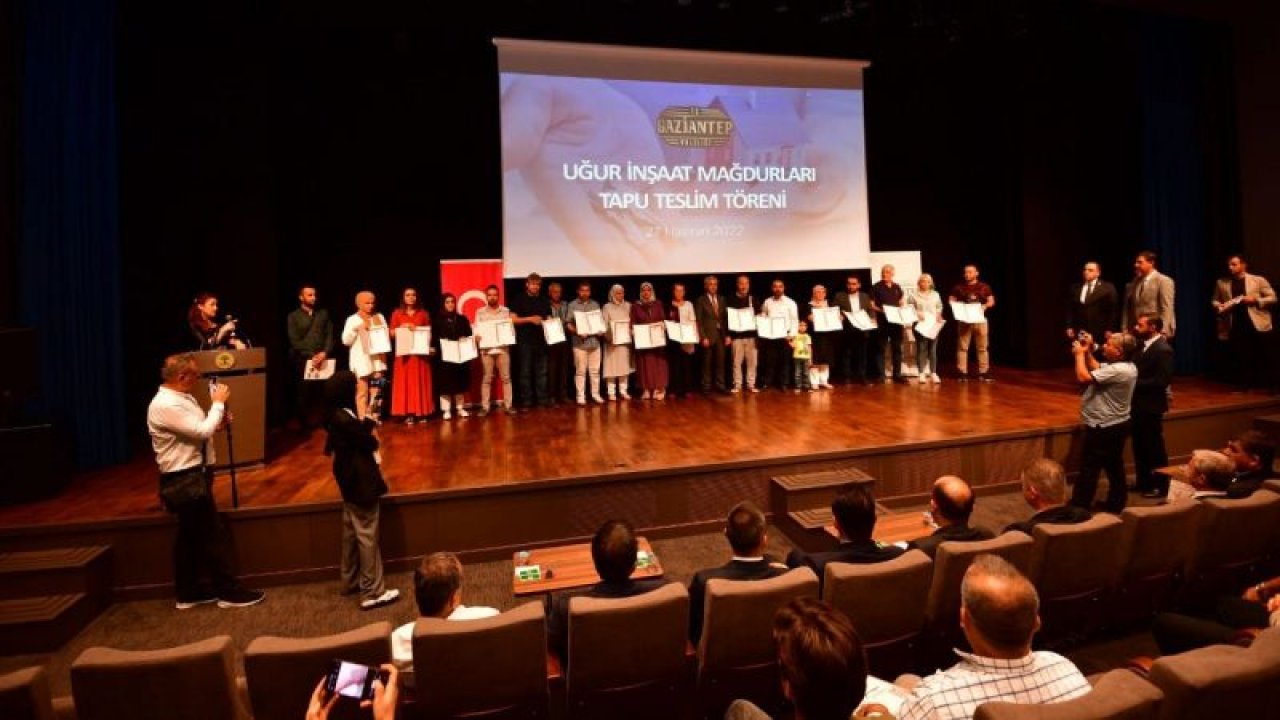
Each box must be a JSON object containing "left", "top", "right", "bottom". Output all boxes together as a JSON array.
[{"left": 18, "top": 0, "right": 127, "bottom": 466}]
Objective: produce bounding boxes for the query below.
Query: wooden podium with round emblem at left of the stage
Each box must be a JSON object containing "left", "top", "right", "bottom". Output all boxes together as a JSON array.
[{"left": 191, "top": 347, "right": 266, "bottom": 471}]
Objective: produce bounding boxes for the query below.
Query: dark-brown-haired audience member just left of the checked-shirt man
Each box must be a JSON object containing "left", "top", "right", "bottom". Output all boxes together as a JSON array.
[{"left": 724, "top": 597, "right": 867, "bottom": 720}]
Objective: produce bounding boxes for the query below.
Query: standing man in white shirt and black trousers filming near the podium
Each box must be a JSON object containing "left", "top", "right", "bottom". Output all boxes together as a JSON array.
[{"left": 147, "top": 354, "right": 265, "bottom": 610}]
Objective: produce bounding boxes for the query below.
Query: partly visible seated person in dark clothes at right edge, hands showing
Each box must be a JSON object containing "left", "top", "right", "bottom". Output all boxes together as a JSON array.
[{"left": 1151, "top": 578, "right": 1280, "bottom": 655}]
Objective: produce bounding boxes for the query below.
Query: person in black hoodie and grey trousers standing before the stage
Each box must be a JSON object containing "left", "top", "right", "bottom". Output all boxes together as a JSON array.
[{"left": 324, "top": 370, "right": 399, "bottom": 610}]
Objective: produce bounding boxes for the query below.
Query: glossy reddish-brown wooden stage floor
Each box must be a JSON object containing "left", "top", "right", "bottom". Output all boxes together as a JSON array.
[{"left": 0, "top": 369, "right": 1280, "bottom": 529}]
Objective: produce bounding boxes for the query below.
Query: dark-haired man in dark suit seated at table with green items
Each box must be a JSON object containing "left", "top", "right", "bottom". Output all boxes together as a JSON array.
[{"left": 545, "top": 520, "right": 667, "bottom": 661}]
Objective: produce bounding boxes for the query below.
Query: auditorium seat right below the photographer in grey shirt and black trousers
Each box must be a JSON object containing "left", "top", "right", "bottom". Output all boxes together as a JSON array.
[{"left": 1107, "top": 502, "right": 1201, "bottom": 628}]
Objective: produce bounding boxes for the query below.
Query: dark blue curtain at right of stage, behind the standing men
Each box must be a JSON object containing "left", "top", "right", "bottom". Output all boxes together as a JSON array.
[{"left": 1139, "top": 15, "right": 1239, "bottom": 373}]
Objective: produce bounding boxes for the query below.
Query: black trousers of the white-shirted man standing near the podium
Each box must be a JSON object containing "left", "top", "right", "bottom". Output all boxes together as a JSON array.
[{"left": 173, "top": 489, "right": 238, "bottom": 600}]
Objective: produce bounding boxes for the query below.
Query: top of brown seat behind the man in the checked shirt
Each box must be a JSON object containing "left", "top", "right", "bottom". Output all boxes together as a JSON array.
[{"left": 973, "top": 670, "right": 1165, "bottom": 720}]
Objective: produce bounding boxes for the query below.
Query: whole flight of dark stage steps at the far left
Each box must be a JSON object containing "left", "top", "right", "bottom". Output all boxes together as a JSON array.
[{"left": 0, "top": 546, "right": 113, "bottom": 655}]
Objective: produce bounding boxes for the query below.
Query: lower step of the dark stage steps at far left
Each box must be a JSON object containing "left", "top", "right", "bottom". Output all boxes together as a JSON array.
[{"left": 0, "top": 592, "right": 97, "bottom": 655}]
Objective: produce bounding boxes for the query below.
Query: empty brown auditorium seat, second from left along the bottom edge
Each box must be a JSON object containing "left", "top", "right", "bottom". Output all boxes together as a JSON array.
[{"left": 72, "top": 635, "right": 249, "bottom": 720}]
